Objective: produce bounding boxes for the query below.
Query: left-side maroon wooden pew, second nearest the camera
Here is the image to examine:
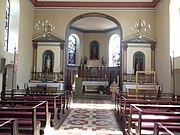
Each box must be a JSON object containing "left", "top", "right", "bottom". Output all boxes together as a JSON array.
[{"left": 0, "top": 101, "right": 50, "bottom": 135}]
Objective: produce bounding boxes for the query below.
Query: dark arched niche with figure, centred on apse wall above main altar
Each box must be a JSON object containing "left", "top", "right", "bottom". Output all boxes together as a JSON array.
[{"left": 90, "top": 41, "right": 99, "bottom": 60}]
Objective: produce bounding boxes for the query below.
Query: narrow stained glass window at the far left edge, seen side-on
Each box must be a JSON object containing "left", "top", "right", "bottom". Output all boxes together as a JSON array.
[{"left": 4, "top": 0, "right": 10, "bottom": 52}]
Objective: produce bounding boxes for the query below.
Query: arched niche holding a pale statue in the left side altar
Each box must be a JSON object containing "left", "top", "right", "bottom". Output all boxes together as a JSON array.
[{"left": 42, "top": 50, "right": 54, "bottom": 73}]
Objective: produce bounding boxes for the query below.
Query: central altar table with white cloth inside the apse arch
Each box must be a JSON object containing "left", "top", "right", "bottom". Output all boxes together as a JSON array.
[{"left": 82, "top": 81, "right": 108, "bottom": 92}]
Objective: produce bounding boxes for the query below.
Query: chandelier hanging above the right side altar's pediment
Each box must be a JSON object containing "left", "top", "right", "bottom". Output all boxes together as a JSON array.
[{"left": 131, "top": 0, "right": 151, "bottom": 38}]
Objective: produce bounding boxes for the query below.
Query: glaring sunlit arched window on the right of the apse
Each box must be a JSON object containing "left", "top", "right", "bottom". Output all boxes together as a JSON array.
[{"left": 109, "top": 34, "right": 120, "bottom": 67}]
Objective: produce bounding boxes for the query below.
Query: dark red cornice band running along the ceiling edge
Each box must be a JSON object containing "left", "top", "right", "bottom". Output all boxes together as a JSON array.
[{"left": 27, "top": 0, "right": 164, "bottom": 9}]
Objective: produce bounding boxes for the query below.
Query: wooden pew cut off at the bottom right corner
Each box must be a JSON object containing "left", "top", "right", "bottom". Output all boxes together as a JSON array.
[{"left": 154, "top": 122, "right": 180, "bottom": 135}]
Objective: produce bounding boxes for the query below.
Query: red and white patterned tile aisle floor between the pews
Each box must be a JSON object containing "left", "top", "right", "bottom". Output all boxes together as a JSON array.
[{"left": 44, "top": 99, "right": 123, "bottom": 135}]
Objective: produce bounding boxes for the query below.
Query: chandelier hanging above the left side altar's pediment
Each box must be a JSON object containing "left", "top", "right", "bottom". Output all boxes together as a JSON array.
[{"left": 34, "top": 0, "right": 55, "bottom": 36}]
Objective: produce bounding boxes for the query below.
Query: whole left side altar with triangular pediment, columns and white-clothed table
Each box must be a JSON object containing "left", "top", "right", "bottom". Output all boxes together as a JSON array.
[{"left": 26, "top": 33, "right": 65, "bottom": 93}]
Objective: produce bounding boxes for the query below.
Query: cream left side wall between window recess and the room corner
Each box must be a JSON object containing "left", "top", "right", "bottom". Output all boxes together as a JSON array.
[{"left": 17, "top": 0, "right": 34, "bottom": 88}]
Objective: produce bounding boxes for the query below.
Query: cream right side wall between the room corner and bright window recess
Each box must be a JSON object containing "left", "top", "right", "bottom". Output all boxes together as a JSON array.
[{"left": 155, "top": 0, "right": 172, "bottom": 92}]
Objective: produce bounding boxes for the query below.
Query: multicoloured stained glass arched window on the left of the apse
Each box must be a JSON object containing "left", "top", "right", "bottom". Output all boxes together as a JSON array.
[{"left": 68, "top": 35, "right": 77, "bottom": 65}]
